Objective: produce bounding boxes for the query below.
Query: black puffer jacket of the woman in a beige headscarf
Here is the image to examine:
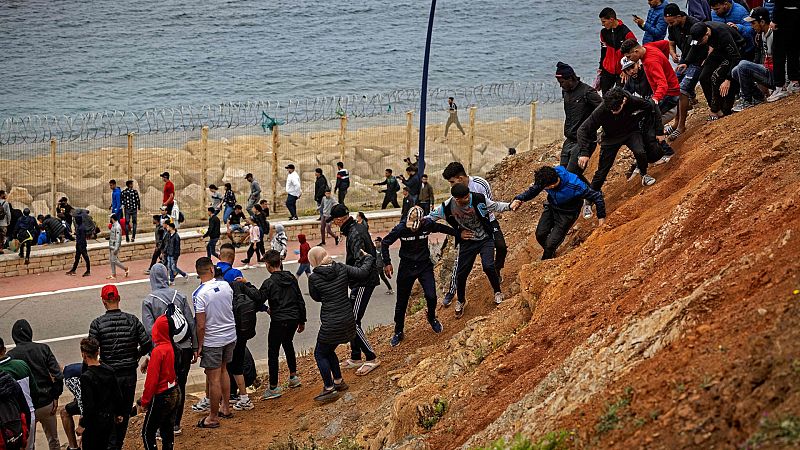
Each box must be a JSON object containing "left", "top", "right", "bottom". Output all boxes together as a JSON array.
[{"left": 308, "top": 255, "right": 375, "bottom": 345}]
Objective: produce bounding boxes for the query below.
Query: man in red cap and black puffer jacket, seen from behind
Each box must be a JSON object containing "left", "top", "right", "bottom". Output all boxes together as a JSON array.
[{"left": 89, "top": 284, "right": 153, "bottom": 449}]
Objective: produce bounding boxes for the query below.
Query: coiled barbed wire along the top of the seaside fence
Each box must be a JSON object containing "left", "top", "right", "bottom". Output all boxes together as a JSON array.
[{"left": 0, "top": 81, "right": 561, "bottom": 145}]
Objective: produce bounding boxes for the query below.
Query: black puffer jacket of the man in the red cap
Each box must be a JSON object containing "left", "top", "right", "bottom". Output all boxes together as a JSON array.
[{"left": 89, "top": 309, "right": 153, "bottom": 375}]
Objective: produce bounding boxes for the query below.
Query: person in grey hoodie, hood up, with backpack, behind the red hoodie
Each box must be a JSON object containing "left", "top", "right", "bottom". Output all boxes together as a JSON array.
[{"left": 140, "top": 263, "right": 199, "bottom": 435}]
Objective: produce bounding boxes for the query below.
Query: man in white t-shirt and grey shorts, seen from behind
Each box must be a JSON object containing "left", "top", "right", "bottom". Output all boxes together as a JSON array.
[{"left": 192, "top": 257, "right": 236, "bottom": 428}]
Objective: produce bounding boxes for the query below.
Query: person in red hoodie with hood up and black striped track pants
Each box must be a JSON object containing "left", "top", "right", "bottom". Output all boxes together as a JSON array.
[{"left": 139, "top": 315, "right": 181, "bottom": 450}]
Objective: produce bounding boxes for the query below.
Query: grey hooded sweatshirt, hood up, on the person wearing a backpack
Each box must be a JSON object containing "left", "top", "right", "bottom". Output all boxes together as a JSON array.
[{"left": 142, "top": 263, "right": 197, "bottom": 350}]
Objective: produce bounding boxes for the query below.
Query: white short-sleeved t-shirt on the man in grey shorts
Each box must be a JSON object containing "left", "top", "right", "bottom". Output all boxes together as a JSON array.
[{"left": 192, "top": 280, "right": 236, "bottom": 348}]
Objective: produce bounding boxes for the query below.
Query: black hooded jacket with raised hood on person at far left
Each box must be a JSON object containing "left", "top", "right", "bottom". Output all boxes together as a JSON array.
[{"left": 8, "top": 319, "right": 64, "bottom": 409}]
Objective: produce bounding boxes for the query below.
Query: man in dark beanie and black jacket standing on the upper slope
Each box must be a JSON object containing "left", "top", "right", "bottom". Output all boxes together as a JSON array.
[{"left": 556, "top": 61, "right": 603, "bottom": 179}]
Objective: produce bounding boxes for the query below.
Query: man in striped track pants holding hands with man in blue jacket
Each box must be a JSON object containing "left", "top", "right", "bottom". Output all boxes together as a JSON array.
[{"left": 428, "top": 181, "right": 509, "bottom": 319}]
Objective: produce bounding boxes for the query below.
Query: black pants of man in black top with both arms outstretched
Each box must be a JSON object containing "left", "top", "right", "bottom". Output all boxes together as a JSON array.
[{"left": 394, "top": 258, "right": 436, "bottom": 334}]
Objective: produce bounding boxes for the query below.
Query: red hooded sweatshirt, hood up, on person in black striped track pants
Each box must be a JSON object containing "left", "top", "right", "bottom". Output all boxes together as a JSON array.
[{"left": 142, "top": 316, "right": 177, "bottom": 408}]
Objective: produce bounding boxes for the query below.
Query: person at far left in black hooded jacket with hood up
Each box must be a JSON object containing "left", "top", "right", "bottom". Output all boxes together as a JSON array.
[{"left": 8, "top": 319, "right": 64, "bottom": 450}]
